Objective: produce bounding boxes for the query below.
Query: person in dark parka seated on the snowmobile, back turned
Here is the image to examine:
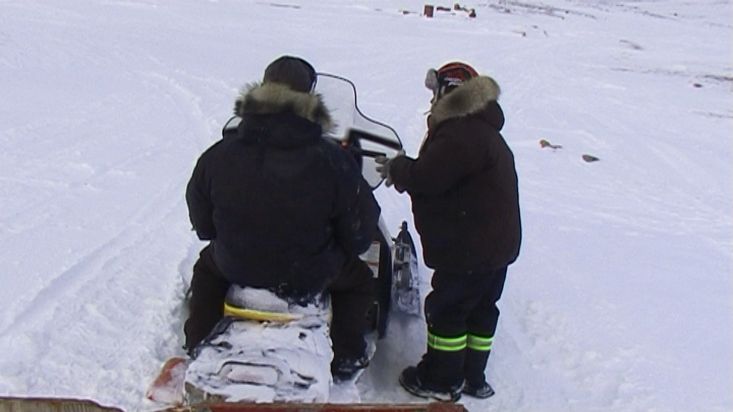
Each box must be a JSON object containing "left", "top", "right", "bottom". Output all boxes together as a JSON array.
[{"left": 184, "top": 56, "right": 379, "bottom": 374}]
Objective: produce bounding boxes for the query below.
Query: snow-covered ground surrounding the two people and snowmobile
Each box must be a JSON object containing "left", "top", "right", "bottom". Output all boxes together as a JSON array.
[{"left": 0, "top": 0, "right": 733, "bottom": 412}]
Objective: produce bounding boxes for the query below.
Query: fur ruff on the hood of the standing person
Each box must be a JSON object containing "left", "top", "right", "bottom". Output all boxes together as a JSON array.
[{"left": 428, "top": 76, "right": 501, "bottom": 128}]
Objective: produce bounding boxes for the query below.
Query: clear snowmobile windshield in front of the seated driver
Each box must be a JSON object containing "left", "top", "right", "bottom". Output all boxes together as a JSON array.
[{"left": 315, "top": 73, "right": 402, "bottom": 189}]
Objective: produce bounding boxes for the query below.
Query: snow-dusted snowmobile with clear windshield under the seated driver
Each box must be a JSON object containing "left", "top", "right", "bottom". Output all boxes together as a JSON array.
[{"left": 147, "top": 73, "right": 420, "bottom": 410}]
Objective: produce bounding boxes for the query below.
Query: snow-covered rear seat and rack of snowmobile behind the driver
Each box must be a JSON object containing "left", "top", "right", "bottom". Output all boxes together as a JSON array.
[{"left": 185, "top": 285, "right": 332, "bottom": 403}]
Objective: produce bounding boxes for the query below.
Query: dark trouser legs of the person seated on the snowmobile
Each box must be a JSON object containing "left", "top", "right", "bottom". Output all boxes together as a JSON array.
[{"left": 184, "top": 246, "right": 374, "bottom": 360}]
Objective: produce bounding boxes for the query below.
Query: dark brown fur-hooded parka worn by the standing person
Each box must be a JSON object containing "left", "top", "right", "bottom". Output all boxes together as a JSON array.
[{"left": 389, "top": 76, "right": 521, "bottom": 272}]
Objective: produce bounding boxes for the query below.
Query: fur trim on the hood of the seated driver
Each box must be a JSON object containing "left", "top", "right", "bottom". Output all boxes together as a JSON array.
[{"left": 234, "top": 83, "right": 333, "bottom": 132}]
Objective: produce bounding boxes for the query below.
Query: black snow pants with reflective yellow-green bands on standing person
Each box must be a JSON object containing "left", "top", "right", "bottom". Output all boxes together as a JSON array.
[{"left": 418, "top": 267, "right": 507, "bottom": 389}]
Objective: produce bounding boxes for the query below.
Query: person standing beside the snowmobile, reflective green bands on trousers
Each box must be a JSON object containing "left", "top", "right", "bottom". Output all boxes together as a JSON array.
[{"left": 377, "top": 62, "right": 521, "bottom": 402}]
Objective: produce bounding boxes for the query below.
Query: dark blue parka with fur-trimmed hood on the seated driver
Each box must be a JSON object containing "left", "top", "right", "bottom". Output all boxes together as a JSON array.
[{"left": 186, "top": 83, "right": 379, "bottom": 301}]
